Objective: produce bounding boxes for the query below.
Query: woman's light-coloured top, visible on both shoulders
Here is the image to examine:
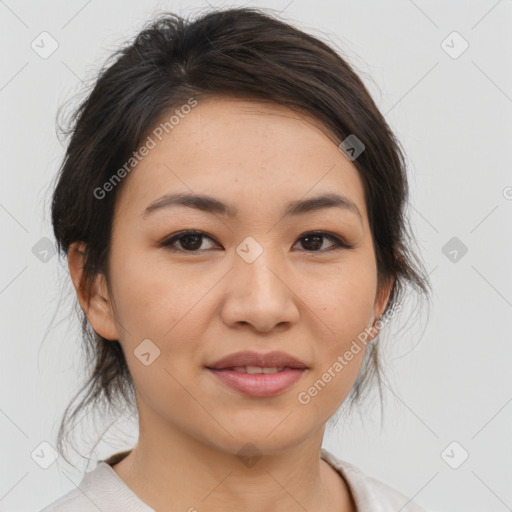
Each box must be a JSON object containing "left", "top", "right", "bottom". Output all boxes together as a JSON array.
[{"left": 40, "top": 448, "right": 425, "bottom": 512}]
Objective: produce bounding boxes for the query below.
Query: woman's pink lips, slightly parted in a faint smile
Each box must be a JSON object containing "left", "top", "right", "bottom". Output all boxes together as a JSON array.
[{"left": 206, "top": 352, "right": 308, "bottom": 397}]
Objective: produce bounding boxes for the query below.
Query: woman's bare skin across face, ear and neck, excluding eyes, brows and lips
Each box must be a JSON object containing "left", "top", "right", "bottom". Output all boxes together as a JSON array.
[{"left": 68, "top": 98, "right": 392, "bottom": 512}]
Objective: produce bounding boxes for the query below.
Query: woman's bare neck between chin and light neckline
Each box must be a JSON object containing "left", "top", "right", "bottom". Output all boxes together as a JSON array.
[{"left": 113, "top": 414, "right": 355, "bottom": 512}]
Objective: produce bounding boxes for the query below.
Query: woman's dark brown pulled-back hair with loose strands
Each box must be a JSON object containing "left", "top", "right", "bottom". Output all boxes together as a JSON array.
[{"left": 51, "top": 8, "right": 430, "bottom": 460}]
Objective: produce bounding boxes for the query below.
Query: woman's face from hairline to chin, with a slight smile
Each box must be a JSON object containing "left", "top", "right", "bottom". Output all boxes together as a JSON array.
[{"left": 90, "top": 98, "right": 387, "bottom": 453}]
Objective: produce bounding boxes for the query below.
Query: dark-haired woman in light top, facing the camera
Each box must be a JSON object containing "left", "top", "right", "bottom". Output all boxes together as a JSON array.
[{"left": 44, "top": 8, "right": 428, "bottom": 512}]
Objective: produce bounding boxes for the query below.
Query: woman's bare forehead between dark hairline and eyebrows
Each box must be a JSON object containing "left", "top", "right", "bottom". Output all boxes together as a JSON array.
[{"left": 113, "top": 98, "right": 366, "bottom": 224}]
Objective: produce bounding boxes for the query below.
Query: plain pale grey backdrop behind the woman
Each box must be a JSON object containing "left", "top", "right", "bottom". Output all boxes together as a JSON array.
[{"left": 0, "top": 0, "right": 512, "bottom": 512}]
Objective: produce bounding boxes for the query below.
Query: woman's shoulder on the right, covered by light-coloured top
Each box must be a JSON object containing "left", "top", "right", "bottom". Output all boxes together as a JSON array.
[{"left": 322, "top": 448, "right": 426, "bottom": 512}]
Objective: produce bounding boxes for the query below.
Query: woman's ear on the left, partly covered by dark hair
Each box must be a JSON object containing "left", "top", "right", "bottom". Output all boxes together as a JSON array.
[{"left": 68, "top": 242, "right": 119, "bottom": 340}]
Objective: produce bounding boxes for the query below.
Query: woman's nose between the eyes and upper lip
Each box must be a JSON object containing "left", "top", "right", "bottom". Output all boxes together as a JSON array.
[{"left": 221, "top": 249, "right": 300, "bottom": 332}]
